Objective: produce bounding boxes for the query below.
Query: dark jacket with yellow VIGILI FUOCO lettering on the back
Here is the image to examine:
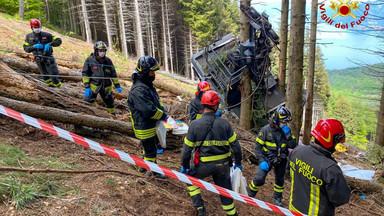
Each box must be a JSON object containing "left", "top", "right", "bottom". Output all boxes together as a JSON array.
[{"left": 289, "top": 143, "right": 351, "bottom": 216}]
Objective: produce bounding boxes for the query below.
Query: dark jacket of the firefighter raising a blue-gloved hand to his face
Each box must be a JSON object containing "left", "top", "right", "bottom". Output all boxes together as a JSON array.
[{"left": 255, "top": 124, "right": 297, "bottom": 165}]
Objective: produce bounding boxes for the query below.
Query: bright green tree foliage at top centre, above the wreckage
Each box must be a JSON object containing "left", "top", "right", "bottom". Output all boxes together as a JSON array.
[{"left": 179, "top": 0, "right": 240, "bottom": 46}]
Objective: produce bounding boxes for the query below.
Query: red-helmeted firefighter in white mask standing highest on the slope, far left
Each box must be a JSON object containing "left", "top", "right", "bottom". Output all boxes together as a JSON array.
[{"left": 23, "top": 19, "right": 62, "bottom": 88}]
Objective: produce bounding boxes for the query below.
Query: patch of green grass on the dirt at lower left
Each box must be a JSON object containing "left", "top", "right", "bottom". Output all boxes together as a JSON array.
[{"left": 0, "top": 143, "right": 72, "bottom": 209}]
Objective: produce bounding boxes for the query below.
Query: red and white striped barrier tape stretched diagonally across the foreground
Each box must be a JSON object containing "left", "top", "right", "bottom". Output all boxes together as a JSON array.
[{"left": 0, "top": 105, "right": 303, "bottom": 216}]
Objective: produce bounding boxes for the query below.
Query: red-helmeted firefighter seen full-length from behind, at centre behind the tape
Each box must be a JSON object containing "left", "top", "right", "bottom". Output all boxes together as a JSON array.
[{"left": 181, "top": 91, "right": 243, "bottom": 216}]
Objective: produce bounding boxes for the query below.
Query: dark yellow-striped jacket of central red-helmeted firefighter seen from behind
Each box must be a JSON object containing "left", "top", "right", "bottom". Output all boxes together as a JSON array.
[{"left": 181, "top": 113, "right": 242, "bottom": 169}]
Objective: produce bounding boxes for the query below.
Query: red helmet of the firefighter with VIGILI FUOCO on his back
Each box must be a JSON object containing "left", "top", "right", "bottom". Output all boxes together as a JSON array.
[{"left": 311, "top": 119, "right": 345, "bottom": 149}]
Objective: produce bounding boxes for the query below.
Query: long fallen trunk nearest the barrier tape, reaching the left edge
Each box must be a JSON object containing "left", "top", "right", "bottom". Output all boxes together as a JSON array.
[{"left": 0, "top": 96, "right": 134, "bottom": 136}]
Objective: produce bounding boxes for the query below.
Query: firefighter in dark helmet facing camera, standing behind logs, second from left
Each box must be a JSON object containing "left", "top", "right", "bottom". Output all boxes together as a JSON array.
[{"left": 82, "top": 41, "right": 121, "bottom": 115}]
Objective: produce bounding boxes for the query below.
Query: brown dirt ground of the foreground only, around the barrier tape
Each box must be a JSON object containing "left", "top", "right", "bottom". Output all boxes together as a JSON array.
[{"left": 0, "top": 112, "right": 384, "bottom": 215}]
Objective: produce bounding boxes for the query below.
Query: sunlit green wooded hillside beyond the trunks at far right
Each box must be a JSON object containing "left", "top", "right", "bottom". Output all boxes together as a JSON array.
[{"left": 328, "top": 67, "right": 382, "bottom": 148}]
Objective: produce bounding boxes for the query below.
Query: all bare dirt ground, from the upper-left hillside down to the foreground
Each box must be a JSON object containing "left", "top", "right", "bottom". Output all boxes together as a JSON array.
[{"left": 0, "top": 13, "right": 384, "bottom": 216}]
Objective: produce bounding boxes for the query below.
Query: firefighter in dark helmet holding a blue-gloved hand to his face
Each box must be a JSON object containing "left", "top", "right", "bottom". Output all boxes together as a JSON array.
[{"left": 248, "top": 106, "right": 297, "bottom": 206}]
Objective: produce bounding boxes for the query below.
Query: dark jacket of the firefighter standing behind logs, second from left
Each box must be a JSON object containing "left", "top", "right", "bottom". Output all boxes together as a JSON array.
[{"left": 82, "top": 53, "right": 120, "bottom": 93}]
